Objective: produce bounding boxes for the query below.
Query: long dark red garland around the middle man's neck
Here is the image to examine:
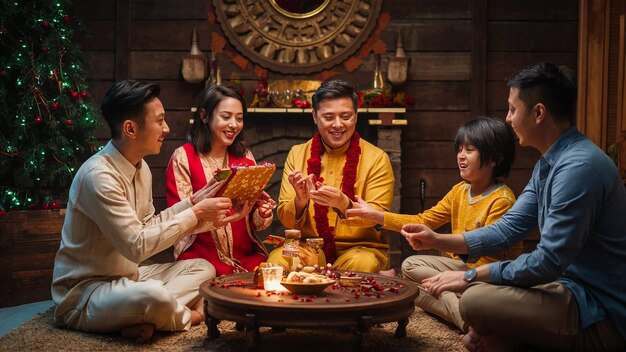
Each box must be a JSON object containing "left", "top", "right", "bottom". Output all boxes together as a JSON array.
[{"left": 307, "top": 131, "right": 361, "bottom": 263}]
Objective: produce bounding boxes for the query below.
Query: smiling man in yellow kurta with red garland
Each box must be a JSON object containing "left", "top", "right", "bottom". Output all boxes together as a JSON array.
[{"left": 268, "top": 80, "right": 394, "bottom": 272}]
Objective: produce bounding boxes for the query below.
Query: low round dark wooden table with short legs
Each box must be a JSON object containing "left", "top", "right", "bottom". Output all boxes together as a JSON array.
[{"left": 200, "top": 273, "right": 419, "bottom": 349}]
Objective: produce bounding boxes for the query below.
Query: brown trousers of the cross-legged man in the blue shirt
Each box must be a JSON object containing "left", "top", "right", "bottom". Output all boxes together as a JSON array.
[{"left": 459, "top": 282, "right": 626, "bottom": 351}]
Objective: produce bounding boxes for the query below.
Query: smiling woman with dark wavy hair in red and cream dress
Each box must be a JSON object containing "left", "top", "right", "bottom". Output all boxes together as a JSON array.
[{"left": 166, "top": 86, "right": 276, "bottom": 275}]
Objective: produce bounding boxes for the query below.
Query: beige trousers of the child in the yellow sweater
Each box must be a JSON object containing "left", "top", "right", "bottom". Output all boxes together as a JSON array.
[{"left": 402, "top": 255, "right": 468, "bottom": 332}]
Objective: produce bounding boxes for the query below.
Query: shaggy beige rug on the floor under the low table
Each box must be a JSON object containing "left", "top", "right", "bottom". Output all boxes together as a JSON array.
[{"left": 0, "top": 308, "right": 465, "bottom": 352}]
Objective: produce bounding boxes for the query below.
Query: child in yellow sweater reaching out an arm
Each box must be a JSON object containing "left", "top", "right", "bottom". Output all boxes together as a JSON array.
[{"left": 346, "top": 117, "right": 522, "bottom": 331}]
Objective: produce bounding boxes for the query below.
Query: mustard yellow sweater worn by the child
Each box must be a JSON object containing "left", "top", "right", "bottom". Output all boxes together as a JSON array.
[{"left": 383, "top": 181, "right": 522, "bottom": 267}]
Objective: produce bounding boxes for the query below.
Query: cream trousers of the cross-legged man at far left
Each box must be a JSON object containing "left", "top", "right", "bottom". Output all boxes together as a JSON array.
[{"left": 64, "top": 259, "right": 215, "bottom": 332}]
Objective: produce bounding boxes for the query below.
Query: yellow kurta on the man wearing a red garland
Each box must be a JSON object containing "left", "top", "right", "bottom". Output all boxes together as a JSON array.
[{"left": 277, "top": 138, "right": 395, "bottom": 270}]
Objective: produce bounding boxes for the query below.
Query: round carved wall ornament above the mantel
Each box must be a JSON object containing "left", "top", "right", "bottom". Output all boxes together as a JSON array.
[{"left": 213, "top": 0, "right": 382, "bottom": 74}]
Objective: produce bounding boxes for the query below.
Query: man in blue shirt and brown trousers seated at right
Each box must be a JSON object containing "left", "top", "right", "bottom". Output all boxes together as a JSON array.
[{"left": 402, "top": 63, "right": 626, "bottom": 351}]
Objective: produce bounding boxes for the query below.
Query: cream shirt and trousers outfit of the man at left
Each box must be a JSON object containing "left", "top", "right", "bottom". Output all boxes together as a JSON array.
[{"left": 52, "top": 142, "right": 215, "bottom": 332}]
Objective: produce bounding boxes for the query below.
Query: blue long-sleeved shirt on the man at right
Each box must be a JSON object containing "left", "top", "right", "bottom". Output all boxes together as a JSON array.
[{"left": 464, "top": 127, "right": 626, "bottom": 338}]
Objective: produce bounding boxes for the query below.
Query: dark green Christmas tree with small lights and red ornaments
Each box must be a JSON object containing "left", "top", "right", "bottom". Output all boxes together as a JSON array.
[{"left": 0, "top": 0, "right": 100, "bottom": 212}]
